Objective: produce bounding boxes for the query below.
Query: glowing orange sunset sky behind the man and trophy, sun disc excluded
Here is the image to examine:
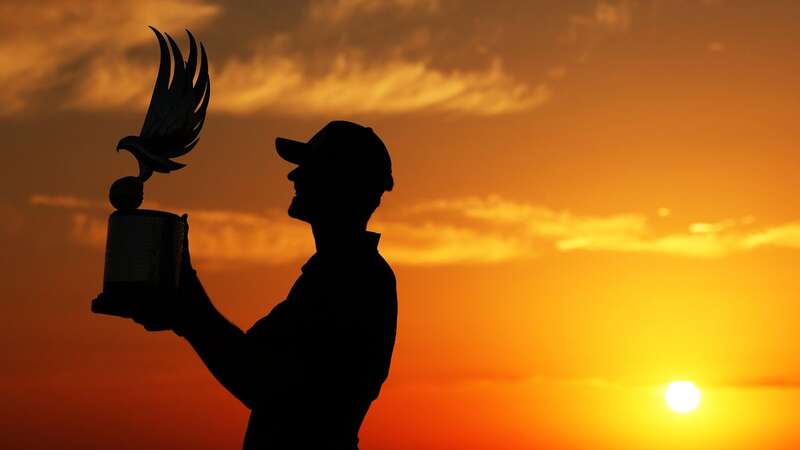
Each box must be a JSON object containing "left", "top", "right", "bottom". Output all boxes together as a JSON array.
[{"left": 0, "top": 0, "right": 800, "bottom": 450}]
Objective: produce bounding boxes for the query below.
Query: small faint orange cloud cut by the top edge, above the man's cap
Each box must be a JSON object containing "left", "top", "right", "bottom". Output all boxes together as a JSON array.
[{"left": 309, "top": 0, "right": 440, "bottom": 24}]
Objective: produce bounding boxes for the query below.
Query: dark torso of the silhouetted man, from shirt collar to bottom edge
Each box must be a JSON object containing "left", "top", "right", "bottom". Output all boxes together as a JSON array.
[{"left": 244, "top": 233, "right": 397, "bottom": 450}]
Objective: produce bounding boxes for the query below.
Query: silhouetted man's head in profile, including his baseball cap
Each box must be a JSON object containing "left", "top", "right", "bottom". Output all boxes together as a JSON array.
[{"left": 275, "top": 121, "right": 394, "bottom": 226}]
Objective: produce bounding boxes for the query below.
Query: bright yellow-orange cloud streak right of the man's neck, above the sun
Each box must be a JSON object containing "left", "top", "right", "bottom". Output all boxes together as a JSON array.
[{"left": 412, "top": 196, "right": 800, "bottom": 258}]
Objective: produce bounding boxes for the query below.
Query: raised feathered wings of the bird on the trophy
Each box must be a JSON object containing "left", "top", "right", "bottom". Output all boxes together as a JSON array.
[{"left": 139, "top": 27, "right": 211, "bottom": 158}]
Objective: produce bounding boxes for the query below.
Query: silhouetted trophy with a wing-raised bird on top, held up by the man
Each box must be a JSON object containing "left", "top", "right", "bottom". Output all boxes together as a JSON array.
[{"left": 92, "top": 27, "right": 211, "bottom": 317}]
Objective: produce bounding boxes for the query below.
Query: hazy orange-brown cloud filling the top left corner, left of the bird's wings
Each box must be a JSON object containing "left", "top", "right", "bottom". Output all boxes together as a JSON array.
[{"left": 0, "top": 0, "right": 220, "bottom": 115}]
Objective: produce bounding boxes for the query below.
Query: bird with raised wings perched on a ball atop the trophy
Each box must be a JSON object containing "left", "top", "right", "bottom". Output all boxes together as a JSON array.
[{"left": 109, "top": 27, "right": 211, "bottom": 210}]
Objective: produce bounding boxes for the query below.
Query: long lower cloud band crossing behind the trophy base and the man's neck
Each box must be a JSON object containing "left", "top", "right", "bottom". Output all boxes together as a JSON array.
[{"left": 30, "top": 195, "right": 800, "bottom": 265}]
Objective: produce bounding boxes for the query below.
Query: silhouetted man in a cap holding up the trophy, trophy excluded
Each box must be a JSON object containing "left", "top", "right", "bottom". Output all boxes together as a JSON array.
[{"left": 97, "top": 121, "right": 397, "bottom": 450}]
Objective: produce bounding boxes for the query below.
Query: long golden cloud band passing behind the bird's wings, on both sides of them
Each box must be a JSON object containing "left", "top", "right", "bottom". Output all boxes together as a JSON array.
[{"left": 67, "top": 43, "right": 551, "bottom": 116}]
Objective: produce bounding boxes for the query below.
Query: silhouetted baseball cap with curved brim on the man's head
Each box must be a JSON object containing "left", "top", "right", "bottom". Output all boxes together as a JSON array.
[{"left": 275, "top": 120, "right": 394, "bottom": 191}]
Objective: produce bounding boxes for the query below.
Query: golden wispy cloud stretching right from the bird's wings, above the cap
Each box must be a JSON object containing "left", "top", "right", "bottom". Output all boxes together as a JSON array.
[{"left": 214, "top": 52, "right": 550, "bottom": 115}]
